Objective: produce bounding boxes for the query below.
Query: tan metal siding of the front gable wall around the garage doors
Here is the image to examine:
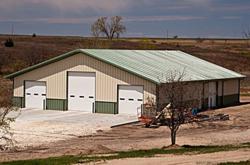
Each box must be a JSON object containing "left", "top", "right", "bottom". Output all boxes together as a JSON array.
[{"left": 14, "top": 54, "right": 156, "bottom": 102}]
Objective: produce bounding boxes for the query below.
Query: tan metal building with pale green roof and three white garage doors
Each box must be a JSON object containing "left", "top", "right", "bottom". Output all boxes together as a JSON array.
[{"left": 6, "top": 49, "right": 245, "bottom": 114}]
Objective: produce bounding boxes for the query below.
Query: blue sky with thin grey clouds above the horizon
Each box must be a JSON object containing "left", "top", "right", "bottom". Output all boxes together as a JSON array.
[{"left": 0, "top": 0, "right": 250, "bottom": 38}]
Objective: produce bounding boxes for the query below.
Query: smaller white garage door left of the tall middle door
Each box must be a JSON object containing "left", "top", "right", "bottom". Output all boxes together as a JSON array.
[{"left": 25, "top": 81, "right": 46, "bottom": 109}]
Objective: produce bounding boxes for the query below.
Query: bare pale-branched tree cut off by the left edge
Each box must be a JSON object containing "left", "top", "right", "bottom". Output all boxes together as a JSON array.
[{"left": 0, "top": 80, "right": 18, "bottom": 150}]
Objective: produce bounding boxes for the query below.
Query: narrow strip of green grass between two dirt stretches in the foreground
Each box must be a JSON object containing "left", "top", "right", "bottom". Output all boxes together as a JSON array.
[{"left": 0, "top": 142, "right": 250, "bottom": 165}]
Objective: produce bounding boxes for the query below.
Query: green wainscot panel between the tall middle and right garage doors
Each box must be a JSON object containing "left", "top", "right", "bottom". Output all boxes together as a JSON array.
[{"left": 95, "top": 101, "right": 118, "bottom": 114}]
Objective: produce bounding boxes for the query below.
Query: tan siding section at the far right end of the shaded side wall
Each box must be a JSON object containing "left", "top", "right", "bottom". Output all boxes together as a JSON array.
[{"left": 224, "top": 79, "right": 239, "bottom": 95}]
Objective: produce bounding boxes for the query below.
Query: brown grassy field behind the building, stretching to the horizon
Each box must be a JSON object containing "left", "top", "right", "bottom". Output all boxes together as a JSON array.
[{"left": 0, "top": 35, "right": 250, "bottom": 92}]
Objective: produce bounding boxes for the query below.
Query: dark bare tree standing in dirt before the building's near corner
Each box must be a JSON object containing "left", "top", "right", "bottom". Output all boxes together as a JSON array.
[{"left": 160, "top": 71, "right": 199, "bottom": 145}]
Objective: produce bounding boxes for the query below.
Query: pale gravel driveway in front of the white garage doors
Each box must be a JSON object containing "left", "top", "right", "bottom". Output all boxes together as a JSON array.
[{"left": 11, "top": 109, "right": 137, "bottom": 147}]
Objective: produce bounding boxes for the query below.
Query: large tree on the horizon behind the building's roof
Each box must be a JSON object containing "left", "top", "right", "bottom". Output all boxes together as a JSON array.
[{"left": 91, "top": 16, "right": 126, "bottom": 40}]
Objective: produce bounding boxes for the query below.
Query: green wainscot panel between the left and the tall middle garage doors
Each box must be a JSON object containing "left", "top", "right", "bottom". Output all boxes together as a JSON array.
[{"left": 46, "top": 98, "right": 67, "bottom": 111}]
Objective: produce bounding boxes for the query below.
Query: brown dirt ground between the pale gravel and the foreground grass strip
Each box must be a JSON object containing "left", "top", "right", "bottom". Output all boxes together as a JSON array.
[{"left": 0, "top": 97, "right": 250, "bottom": 161}]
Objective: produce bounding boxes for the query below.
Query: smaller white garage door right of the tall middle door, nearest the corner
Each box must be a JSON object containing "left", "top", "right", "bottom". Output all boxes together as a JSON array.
[{"left": 118, "top": 85, "right": 143, "bottom": 115}]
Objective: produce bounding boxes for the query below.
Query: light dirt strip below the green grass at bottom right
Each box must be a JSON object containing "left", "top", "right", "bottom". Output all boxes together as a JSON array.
[{"left": 101, "top": 150, "right": 250, "bottom": 165}]
